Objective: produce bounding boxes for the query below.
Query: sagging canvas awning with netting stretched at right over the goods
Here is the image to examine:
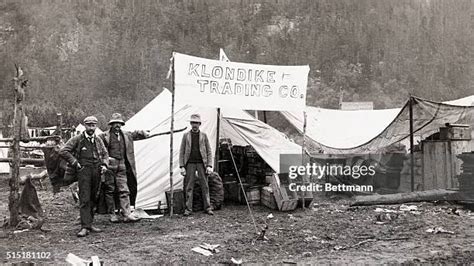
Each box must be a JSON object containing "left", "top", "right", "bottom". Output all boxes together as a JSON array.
[{"left": 281, "top": 96, "right": 474, "bottom": 153}]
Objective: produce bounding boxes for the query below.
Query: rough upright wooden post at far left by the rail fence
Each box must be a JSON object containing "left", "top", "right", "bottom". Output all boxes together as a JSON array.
[{"left": 8, "top": 66, "right": 26, "bottom": 227}]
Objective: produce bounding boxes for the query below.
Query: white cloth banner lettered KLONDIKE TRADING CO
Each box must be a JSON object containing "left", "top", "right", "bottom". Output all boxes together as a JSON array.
[{"left": 174, "top": 53, "right": 309, "bottom": 110}]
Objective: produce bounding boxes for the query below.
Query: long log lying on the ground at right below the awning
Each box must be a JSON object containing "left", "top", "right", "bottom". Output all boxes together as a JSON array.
[{"left": 350, "top": 189, "right": 462, "bottom": 206}]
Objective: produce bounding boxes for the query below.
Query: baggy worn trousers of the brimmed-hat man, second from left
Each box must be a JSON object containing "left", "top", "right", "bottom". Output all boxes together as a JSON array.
[{"left": 105, "top": 158, "right": 130, "bottom": 216}]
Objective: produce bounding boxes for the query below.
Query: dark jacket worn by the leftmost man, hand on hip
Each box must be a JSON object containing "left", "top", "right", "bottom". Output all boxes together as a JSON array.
[{"left": 59, "top": 132, "right": 109, "bottom": 167}]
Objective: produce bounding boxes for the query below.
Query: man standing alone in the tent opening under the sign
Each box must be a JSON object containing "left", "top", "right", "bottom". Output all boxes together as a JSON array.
[{"left": 179, "top": 114, "right": 214, "bottom": 216}]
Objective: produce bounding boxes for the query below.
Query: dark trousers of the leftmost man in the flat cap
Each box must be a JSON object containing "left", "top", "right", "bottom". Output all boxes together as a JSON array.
[{"left": 77, "top": 164, "right": 100, "bottom": 229}]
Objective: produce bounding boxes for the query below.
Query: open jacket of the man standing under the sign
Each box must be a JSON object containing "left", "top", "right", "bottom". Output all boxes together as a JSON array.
[{"left": 179, "top": 131, "right": 213, "bottom": 167}]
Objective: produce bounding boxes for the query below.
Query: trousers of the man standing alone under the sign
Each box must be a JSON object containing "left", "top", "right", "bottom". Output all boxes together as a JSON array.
[{"left": 185, "top": 163, "right": 211, "bottom": 212}]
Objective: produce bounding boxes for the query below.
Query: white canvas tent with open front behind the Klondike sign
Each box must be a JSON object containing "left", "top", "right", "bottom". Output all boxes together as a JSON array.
[{"left": 124, "top": 90, "right": 301, "bottom": 209}]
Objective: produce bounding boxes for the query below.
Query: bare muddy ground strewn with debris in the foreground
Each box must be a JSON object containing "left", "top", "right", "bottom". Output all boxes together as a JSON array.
[{"left": 0, "top": 177, "right": 474, "bottom": 264}]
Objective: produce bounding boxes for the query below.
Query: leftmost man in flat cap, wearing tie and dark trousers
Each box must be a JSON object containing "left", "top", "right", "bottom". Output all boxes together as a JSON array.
[{"left": 59, "top": 116, "right": 109, "bottom": 237}]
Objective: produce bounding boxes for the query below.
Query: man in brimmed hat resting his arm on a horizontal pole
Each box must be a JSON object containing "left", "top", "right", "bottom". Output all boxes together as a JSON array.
[{"left": 99, "top": 113, "right": 150, "bottom": 223}]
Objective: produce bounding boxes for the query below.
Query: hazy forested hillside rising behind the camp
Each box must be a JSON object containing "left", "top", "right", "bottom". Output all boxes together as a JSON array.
[{"left": 0, "top": 0, "right": 474, "bottom": 126}]
